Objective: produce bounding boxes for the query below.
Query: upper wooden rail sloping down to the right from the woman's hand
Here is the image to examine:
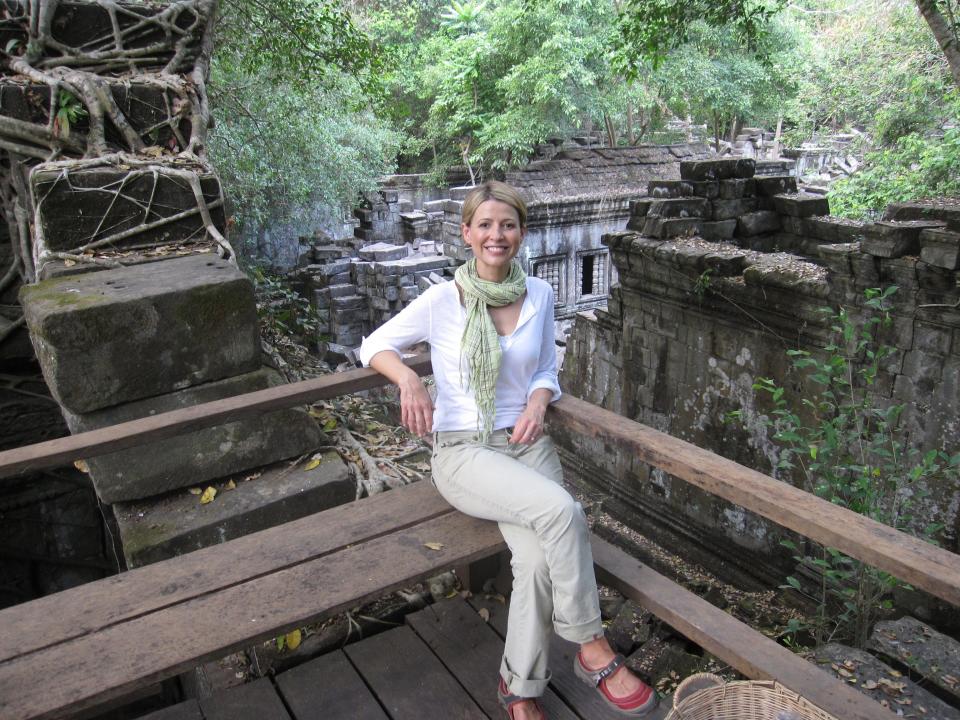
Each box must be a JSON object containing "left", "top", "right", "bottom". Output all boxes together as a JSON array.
[{"left": 550, "top": 395, "right": 960, "bottom": 606}]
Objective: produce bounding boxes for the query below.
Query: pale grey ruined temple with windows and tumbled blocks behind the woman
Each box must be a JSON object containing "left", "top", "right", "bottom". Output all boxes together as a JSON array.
[{"left": 291, "top": 145, "right": 728, "bottom": 361}]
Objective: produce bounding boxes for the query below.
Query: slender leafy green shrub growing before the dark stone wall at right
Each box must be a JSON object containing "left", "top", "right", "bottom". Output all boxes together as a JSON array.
[{"left": 736, "top": 287, "right": 960, "bottom": 647}]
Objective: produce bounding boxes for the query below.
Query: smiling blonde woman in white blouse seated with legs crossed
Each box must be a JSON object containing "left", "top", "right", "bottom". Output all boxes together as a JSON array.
[{"left": 360, "top": 182, "right": 657, "bottom": 720}]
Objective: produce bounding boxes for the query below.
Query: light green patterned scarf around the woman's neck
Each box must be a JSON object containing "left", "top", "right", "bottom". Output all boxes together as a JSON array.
[{"left": 456, "top": 260, "right": 527, "bottom": 443}]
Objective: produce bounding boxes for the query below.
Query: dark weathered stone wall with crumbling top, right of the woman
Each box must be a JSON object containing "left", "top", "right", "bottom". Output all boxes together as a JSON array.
[{"left": 560, "top": 161, "right": 960, "bottom": 600}]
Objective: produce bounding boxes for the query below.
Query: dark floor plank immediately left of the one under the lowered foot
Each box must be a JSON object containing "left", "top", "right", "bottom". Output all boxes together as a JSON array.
[{"left": 344, "top": 627, "right": 488, "bottom": 720}]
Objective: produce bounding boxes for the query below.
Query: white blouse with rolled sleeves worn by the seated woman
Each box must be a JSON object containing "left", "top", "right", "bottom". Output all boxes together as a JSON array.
[{"left": 360, "top": 277, "right": 560, "bottom": 432}]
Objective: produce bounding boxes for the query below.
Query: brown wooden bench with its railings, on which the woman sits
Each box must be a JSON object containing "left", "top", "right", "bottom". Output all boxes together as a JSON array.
[{"left": 0, "top": 358, "right": 960, "bottom": 720}]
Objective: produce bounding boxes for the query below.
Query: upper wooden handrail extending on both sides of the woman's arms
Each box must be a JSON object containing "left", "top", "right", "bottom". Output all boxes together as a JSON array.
[{"left": 0, "top": 355, "right": 960, "bottom": 606}]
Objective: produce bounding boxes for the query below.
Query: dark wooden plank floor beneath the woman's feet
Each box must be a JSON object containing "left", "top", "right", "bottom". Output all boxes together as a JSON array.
[{"left": 143, "top": 598, "right": 668, "bottom": 720}]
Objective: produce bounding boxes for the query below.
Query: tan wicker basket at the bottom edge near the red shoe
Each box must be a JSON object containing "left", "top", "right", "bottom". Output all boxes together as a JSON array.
[{"left": 666, "top": 673, "right": 837, "bottom": 720}]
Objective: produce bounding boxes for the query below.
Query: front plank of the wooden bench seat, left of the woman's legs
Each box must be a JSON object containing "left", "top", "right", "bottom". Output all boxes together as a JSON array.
[{"left": 0, "top": 512, "right": 504, "bottom": 720}]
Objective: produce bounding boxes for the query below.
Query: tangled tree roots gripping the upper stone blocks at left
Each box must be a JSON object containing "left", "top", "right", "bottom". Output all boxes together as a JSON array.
[{"left": 0, "top": 0, "right": 233, "bottom": 298}]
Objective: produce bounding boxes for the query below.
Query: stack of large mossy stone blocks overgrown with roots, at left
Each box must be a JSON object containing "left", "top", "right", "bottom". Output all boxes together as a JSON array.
[{"left": 0, "top": 0, "right": 356, "bottom": 584}]
